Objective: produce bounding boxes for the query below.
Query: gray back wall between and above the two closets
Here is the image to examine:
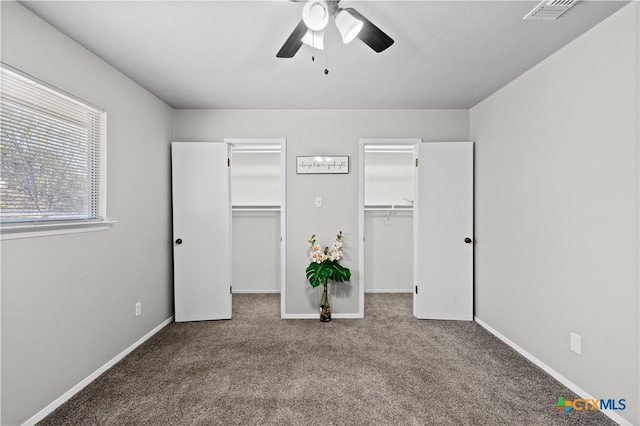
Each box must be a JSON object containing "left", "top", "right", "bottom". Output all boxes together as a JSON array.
[{"left": 175, "top": 110, "right": 469, "bottom": 315}]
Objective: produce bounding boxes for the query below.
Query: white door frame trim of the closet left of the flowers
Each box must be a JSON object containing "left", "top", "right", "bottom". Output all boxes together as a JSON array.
[{"left": 224, "top": 138, "right": 287, "bottom": 318}]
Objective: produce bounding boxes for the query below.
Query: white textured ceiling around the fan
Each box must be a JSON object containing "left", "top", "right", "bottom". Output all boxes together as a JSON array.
[{"left": 21, "top": 0, "right": 626, "bottom": 109}]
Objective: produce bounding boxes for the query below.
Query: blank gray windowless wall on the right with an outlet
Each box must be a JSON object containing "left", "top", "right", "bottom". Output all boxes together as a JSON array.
[{"left": 470, "top": 2, "right": 640, "bottom": 424}]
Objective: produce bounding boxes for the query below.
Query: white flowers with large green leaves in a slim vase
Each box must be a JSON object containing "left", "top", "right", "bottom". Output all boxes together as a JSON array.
[{"left": 307, "top": 231, "right": 351, "bottom": 322}]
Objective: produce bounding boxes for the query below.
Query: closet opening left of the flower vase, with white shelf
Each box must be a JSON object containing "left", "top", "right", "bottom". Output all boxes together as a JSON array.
[{"left": 225, "top": 139, "right": 286, "bottom": 306}]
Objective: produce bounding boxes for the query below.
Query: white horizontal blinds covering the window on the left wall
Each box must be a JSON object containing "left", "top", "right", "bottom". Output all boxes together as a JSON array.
[{"left": 0, "top": 64, "right": 106, "bottom": 225}]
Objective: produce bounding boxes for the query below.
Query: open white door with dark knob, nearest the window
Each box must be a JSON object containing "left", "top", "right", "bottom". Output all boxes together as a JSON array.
[{"left": 171, "top": 142, "right": 231, "bottom": 321}]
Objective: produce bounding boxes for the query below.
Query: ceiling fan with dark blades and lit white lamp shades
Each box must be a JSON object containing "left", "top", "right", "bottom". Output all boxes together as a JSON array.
[{"left": 276, "top": 0, "right": 393, "bottom": 58}]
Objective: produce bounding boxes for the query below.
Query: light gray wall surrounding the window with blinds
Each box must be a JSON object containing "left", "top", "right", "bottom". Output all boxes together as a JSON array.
[{"left": 0, "top": 1, "right": 173, "bottom": 425}]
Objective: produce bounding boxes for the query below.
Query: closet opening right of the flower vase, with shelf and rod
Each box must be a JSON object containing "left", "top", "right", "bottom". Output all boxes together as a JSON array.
[{"left": 360, "top": 139, "right": 420, "bottom": 314}]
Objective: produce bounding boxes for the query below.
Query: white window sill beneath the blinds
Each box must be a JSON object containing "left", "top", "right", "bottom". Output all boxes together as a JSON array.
[{"left": 0, "top": 220, "right": 116, "bottom": 241}]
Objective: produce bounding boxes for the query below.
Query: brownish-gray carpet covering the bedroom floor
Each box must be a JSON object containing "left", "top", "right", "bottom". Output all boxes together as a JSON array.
[{"left": 41, "top": 294, "right": 615, "bottom": 425}]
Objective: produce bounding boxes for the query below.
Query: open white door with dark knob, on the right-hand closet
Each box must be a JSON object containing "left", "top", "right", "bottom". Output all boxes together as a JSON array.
[{"left": 413, "top": 142, "right": 473, "bottom": 321}]
